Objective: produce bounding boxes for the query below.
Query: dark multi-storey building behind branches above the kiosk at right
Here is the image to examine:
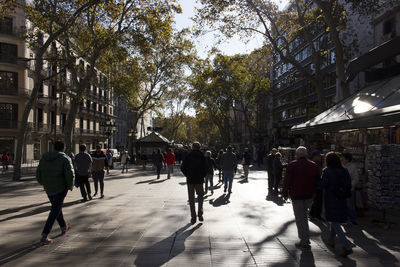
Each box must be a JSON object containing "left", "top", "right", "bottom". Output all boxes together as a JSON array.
[{"left": 271, "top": 3, "right": 373, "bottom": 146}]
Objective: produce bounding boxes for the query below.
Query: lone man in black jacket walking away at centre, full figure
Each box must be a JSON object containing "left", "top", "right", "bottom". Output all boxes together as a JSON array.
[{"left": 181, "top": 142, "right": 207, "bottom": 224}]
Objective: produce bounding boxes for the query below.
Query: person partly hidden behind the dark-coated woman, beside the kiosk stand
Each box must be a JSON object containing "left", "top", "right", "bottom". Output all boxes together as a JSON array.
[{"left": 341, "top": 153, "right": 360, "bottom": 225}]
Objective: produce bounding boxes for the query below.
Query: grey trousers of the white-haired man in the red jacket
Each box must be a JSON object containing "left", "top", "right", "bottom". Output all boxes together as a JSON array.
[{"left": 292, "top": 198, "right": 312, "bottom": 245}]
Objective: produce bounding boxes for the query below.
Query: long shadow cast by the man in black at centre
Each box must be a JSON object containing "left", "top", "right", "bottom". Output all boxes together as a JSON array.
[{"left": 134, "top": 223, "right": 202, "bottom": 266}]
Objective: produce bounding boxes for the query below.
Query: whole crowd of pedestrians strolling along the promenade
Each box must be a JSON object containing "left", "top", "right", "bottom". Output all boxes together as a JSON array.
[{"left": 37, "top": 141, "right": 358, "bottom": 256}]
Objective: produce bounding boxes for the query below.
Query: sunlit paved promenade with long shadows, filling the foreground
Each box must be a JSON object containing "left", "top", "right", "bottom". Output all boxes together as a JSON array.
[{"left": 0, "top": 167, "right": 400, "bottom": 267}]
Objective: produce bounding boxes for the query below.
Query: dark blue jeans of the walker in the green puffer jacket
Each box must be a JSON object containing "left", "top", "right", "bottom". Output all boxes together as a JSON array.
[{"left": 42, "top": 189, "right": 67, "bottom": 237}]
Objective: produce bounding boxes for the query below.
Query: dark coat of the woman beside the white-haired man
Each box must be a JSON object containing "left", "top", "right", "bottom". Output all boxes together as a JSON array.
[{"left": 322, "top": 168, "right": 351, "bottom": 223}]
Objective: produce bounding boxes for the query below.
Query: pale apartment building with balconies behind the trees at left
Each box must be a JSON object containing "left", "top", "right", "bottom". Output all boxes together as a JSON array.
[{"left": 0, "top": 6, "right": 116, "bottom": 162}]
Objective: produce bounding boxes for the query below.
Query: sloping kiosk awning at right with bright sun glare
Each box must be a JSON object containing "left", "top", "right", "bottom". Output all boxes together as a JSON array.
[{"left": 292, "top": 75, "right": 400, "bottom": 133}]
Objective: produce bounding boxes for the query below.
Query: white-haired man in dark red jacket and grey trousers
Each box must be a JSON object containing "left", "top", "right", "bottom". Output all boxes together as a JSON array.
[{"left": 283, "top": 146, "right": 321, "bottom": 249}]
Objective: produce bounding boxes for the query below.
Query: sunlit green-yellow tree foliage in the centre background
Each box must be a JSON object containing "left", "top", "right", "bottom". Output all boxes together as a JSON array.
[{"left": 191, "top": 50, "right": 270, "bottom": 147}]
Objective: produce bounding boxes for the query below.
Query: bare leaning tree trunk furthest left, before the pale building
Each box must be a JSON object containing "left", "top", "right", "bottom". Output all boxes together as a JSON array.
[{"left": 13, "top": 53, "right": 44, "bottom": 181}]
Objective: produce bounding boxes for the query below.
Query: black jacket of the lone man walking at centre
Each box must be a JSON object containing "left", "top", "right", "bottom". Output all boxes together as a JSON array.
[{"left": 181, "top": 150, "right": 207, "bottom": 184}]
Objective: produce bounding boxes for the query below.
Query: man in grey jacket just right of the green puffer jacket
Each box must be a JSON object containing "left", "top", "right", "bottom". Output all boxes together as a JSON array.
[{"left": 74, "top": 145, "right": 93, "bottom": 202}]
